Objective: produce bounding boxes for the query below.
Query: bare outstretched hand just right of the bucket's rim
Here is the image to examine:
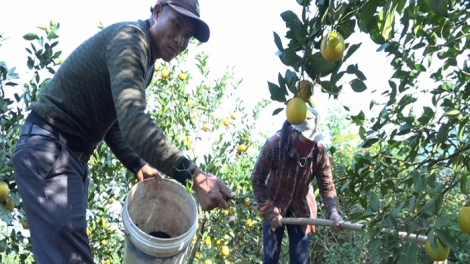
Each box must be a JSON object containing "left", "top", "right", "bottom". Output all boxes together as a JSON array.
[{"left": 193, "top": 169, "right": 235, "bottom": 211}]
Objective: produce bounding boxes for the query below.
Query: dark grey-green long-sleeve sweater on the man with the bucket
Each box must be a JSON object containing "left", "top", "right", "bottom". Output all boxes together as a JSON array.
[{"left": 32, "top": 21, "right": 194, "bottom": 178}]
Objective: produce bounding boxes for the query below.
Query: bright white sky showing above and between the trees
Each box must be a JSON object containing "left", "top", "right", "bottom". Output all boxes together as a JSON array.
[{"left": 0, "top": 0, "right": 392, "bottom": 138}]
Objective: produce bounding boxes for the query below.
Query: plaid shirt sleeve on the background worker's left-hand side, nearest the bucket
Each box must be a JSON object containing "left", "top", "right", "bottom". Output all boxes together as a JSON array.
[{"left": 251, "top": 139, "right": 277, "bottom": 224}]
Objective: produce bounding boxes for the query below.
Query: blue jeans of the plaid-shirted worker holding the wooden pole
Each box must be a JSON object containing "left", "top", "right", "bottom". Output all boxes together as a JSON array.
[{"left": 263, "top": 212, "right": 309, "bottom": 264}]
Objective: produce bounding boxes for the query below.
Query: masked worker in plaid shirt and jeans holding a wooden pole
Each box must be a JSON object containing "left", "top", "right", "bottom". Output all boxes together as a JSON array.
[{"left": 251, "top": 107, "right": 343, "bottom": 264}]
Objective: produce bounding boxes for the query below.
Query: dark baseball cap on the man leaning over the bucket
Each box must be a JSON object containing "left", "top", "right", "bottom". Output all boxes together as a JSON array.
[{"left": 157, "top": 0, "right": 210, "bottom": 42}]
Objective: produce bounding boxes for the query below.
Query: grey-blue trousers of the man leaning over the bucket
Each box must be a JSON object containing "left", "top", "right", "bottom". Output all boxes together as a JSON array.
[{"left": 13, "top": 127, "right": 93, "bottom": 264}]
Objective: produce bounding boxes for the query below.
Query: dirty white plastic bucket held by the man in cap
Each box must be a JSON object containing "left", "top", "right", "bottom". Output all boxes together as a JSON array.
[{"left": 122, "top": 178, "right": 198, "bottom": 264}]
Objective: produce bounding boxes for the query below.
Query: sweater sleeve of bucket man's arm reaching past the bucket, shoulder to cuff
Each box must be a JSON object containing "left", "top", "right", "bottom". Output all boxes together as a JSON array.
[{"left": 106, "top": 23, "right": 196, "bottom": 183}]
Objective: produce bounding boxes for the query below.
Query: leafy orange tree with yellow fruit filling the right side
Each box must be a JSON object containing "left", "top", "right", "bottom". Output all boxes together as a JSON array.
[{"left": 268, "top": 0, "right": 470, "bottom": 263}]
